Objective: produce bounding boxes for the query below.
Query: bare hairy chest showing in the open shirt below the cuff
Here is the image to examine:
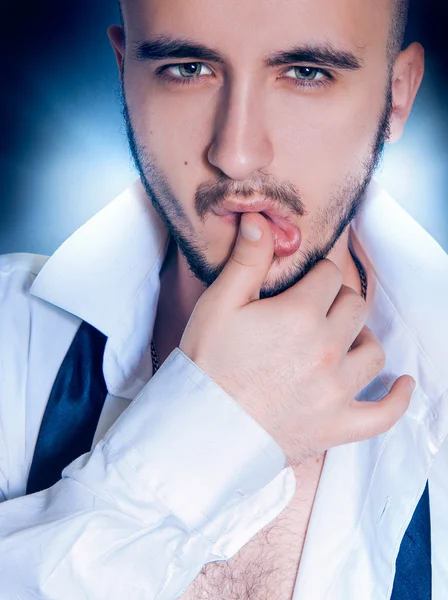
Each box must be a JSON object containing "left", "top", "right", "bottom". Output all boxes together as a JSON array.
[{"left": 180, "top": 457, "right": 324, "bottom": 600}]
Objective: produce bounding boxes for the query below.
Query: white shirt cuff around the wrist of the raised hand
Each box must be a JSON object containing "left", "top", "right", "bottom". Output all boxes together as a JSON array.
[{"left": 80, "top": 348, "right": 290, "bottom": 541}]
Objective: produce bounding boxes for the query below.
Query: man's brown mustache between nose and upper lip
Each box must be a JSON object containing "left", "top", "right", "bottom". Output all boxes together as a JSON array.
[{"left": 195, "top": 173, "right": 308, "bottom": 221}]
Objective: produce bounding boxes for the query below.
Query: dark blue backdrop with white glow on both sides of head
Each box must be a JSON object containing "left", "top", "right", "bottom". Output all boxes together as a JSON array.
[{"left": 0, "top": 0, "right": 448, "bottom": 254}]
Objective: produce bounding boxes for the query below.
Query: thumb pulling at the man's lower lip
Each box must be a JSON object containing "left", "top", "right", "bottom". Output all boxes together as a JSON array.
[{"left": 211, "top": 213, "right": 274, "bottom": 306}]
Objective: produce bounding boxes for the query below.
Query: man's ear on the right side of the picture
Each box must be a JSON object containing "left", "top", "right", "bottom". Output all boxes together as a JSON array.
[{"left": 387, "top": 42, "right": 425, "bottom": 143}]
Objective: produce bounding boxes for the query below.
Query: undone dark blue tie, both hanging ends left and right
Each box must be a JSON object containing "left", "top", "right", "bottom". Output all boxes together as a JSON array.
[{"left": 27, "top": 322, "right": 431, "bottom": 600}]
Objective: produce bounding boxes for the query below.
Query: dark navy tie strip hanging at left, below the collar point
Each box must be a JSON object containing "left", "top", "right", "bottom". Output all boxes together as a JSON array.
[{"left": 26, "top": 321, "right": 107, "bottom": 494}]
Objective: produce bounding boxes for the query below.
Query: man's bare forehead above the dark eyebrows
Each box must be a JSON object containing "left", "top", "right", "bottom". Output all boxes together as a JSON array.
[{"left": 122, "top": 0, "right": 392, "bottom": 59}]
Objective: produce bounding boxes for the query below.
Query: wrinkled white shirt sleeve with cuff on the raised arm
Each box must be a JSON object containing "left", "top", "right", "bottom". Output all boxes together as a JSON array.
[{"left": 0, "top": 349, "right": 295, "bottom": 600}]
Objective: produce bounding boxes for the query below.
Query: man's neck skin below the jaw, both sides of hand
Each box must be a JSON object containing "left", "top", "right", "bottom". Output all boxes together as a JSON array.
[{"left": 153, "top": 227, "right": 362, "bottom": 364}]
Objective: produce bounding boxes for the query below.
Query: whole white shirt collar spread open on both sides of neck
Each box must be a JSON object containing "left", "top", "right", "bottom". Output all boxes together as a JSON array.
[{"left": 31, "top": 180, "right": 448, "bottom": 399}]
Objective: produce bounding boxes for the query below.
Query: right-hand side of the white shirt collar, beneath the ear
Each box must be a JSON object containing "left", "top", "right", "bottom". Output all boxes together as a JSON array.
[{"left": 350, "top": 181, "right": 448, "bottom": 404}]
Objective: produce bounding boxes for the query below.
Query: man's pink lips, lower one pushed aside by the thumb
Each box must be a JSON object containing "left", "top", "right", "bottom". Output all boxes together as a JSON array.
[{"left": 212, "top": 200, "right": 302, "bottom": 257}]
